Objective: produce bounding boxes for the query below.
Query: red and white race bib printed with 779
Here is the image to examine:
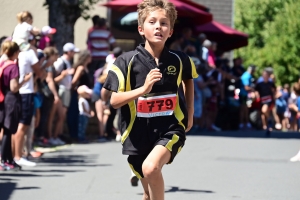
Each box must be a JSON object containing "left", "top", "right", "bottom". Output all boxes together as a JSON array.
[{"left": 137, "top": 94, "right": 177, "bottom": 118}]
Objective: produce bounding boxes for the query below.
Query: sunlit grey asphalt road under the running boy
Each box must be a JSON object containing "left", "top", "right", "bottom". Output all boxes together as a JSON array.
[{"left": 0, "top": 131, "right": 300, "bottom": 200}]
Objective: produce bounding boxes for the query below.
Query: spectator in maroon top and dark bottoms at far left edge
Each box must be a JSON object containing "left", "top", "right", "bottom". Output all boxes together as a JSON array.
[{"left": 0, "top": 41, "right": 34, "bottom": 170}]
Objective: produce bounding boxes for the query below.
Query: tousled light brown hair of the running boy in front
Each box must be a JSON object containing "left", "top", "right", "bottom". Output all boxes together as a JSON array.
[{"left": 137, "top": 0, "right": 177, "bottom": 29}]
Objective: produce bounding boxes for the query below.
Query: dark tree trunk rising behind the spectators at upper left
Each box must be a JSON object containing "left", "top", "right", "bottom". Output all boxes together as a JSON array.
[{"left": 46, "top": 0, "right": 81, "bottom": 54}]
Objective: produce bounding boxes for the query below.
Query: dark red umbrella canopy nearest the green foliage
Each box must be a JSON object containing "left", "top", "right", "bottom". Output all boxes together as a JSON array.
[{"left": 196, "top": 21, "right": 248, "bottom": 51}]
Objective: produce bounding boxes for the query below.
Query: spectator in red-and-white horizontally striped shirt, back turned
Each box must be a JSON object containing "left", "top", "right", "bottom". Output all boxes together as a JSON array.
[{"left": 87, "top": 16, "right": 116, "bottom": 76}]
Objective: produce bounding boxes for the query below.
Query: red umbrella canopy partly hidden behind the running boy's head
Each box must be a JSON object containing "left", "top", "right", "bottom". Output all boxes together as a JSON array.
[{"left": 102, "top": 0, "right": 212, "bottom": 25}]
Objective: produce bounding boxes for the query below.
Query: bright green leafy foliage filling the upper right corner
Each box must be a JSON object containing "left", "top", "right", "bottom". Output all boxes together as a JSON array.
[{"left": 235, "top": 0, "right": 300, "bottom": 84}]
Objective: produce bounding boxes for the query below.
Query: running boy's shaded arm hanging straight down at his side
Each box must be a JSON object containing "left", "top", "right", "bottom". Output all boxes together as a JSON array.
[{"left": 183, "top": 79, "right": 194, "bottom": 132}]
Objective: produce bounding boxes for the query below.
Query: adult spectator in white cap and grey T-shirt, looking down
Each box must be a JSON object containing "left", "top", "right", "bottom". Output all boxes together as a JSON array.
[{"left": 49, "top": 43, "right": 79, "bottom": 145}]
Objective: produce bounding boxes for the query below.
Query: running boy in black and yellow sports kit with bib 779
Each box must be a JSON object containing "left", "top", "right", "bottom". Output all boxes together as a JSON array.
[{"left": 104, "top": 0, "right": 198, "bottom": 200}]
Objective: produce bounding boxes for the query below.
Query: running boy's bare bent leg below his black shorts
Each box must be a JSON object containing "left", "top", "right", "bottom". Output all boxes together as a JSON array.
[{"left": 142, "top": 145, "right": 171, "bottom": 200}]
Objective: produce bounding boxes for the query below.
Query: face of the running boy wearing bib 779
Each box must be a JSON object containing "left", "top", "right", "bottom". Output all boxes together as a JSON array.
[{"left": 138, "top": 9, "right": 173, "bottom": 45}]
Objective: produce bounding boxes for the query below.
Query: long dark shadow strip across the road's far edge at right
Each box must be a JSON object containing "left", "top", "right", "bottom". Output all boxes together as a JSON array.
[{"left": 187, "top": 130, "right": 300, "bottom": 139}]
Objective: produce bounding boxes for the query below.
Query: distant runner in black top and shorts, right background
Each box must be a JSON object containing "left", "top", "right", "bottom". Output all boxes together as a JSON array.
[{"left": 255, "top": 71, "right": 276, "bottom": 130}]
